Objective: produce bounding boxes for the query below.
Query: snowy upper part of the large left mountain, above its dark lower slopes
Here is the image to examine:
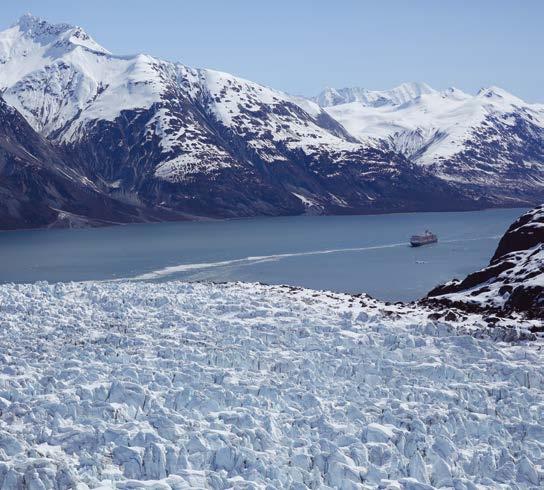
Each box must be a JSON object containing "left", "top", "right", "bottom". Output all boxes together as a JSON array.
[{"left": 0, "top": 16, "right": 370, "bottom": 181}]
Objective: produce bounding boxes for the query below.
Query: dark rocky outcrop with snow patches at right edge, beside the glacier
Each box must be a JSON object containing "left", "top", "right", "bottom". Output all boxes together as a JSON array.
[{"left": 426, "top": 205, "right": 544, "bottom": 319}]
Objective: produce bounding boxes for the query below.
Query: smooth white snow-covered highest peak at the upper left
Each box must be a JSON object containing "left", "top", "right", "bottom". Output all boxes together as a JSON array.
[{"left": 0, "top": 16, "right": 163, "bottom": 141}]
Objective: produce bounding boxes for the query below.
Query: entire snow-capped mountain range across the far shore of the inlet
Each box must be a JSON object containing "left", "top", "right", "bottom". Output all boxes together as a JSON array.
[{"left": 0, "top": 15, "right": 544, "bottom": 228}]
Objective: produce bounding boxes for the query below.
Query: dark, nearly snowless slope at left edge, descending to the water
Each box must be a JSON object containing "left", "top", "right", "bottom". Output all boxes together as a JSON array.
[{"left": 0, "top": 98, "right": 158, "bottom": 229}]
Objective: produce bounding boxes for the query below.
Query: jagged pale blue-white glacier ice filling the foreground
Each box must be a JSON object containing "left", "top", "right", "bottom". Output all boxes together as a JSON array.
[{"left": 0, "top": 282, "right": 544, "bottom": 489}]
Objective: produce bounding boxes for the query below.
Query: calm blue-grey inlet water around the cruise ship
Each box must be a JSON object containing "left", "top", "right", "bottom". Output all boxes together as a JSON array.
[{"left": 0, "top": 209, "right": 523, "bottom": 300}]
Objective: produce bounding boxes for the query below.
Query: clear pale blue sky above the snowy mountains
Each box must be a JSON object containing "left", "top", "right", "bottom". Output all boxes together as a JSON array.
[{"left": 0, "top": 0, "right": 544, "bottom": 102}]
